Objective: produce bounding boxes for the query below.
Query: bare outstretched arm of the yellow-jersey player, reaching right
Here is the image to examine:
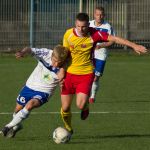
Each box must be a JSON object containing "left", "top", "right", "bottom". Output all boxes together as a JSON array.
[{"left": 108, "top": 35, "right": 147, "bottom": 54}]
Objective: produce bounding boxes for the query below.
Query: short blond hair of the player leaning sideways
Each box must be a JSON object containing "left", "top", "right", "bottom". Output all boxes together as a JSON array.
[{"left": 53, "top": 45, "right": 69, "bottom": 62}]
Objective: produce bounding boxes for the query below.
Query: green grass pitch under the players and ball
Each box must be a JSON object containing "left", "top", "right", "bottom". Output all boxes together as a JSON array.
[{"left": 0, "top": 53, "right": 150, "bottom": 150}]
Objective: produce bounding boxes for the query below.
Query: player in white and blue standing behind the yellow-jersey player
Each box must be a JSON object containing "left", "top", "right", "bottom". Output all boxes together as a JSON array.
[{"left": 89, "top": 7, "right": 115, "bottom": 103}]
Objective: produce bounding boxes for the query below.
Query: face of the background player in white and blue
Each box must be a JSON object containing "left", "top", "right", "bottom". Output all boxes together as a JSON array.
[{"left": 94, "top": 9, "right": 104, "bottom": 23}]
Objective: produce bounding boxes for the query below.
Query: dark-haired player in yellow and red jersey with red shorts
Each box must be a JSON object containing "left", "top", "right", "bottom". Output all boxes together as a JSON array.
[{"left": 61, "top": 13, "right": 147, "bottom": 133}]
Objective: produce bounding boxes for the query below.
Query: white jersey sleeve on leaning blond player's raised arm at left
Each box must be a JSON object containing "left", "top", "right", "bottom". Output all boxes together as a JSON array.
[{"left": 31, "top": 48, "right": 50, "bottom": 60}]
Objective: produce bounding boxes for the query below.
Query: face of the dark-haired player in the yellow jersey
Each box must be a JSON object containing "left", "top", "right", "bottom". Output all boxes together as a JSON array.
[{"left": 76, "top": 20, "right": 89, "bottom": 36}]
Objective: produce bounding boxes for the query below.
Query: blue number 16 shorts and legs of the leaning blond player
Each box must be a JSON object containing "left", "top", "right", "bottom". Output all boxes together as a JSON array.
[{"left": 1, "top": 86, "right": 49, "bottom": 137}]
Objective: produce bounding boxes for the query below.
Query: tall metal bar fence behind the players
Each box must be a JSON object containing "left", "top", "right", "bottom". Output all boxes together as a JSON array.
[{"left": 0, "top": 0, "right": 150, "bottom": 51}]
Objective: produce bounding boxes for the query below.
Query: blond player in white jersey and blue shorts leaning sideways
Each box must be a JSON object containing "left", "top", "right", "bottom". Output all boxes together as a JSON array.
[{"left": 0, "top": 45, "right": 68, "bottom": 138}]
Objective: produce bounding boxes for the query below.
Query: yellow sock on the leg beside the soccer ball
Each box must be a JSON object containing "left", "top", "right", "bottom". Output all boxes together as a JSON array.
[{"left": 60, "top": 108, "right": 72, "bottom": 131}]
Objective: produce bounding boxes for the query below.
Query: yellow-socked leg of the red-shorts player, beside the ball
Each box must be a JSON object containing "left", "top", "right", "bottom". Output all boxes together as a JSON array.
[{"left": 61, "top": 95, "right": 73, "bottom": 133}]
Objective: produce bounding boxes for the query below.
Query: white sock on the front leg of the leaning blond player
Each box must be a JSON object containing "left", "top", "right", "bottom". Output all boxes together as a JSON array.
[{"left": 6, "top": 108, "right": 29, "bottom": 128}]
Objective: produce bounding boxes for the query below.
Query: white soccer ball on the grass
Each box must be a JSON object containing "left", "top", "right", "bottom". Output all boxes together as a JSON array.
[{"left": 53, "top": 127, "right": 71, "bottom": 144}]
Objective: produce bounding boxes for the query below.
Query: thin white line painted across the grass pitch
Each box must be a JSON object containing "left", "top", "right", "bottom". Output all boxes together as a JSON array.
[{"left": 0, "top": 111, "right": 150, "bottom": 115}]
